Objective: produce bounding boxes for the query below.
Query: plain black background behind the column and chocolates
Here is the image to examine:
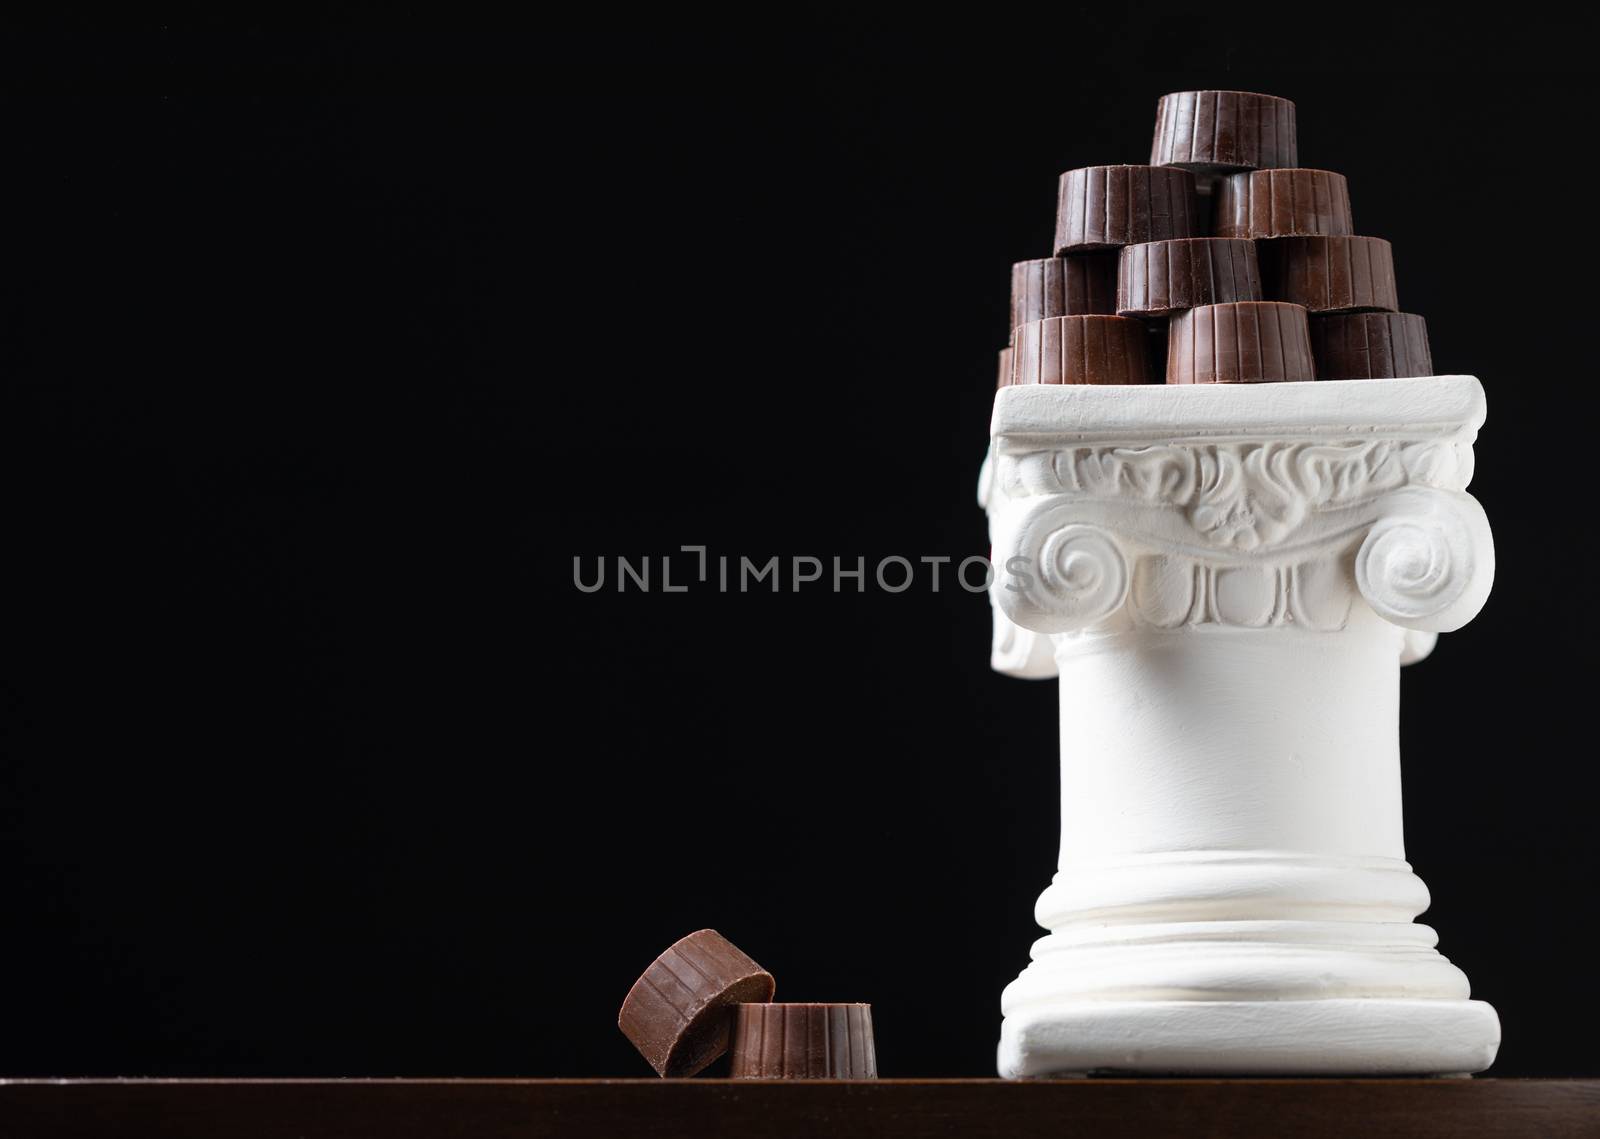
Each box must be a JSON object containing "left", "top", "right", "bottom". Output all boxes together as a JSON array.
[{"left": 0, "top": 17, "right": 1600, "bottom": 1075}]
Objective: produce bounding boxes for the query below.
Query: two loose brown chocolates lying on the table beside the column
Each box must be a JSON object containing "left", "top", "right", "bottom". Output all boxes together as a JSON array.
[{"left": 616, "top": 929, "right": 878, "bottom": 1080}]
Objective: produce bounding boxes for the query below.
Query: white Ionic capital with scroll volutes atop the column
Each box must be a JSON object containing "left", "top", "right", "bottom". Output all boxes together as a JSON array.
[{"left": 984, "top": 376, "right": 1494, "bottom": 659}]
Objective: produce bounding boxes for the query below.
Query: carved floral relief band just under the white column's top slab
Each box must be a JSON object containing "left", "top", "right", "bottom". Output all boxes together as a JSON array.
[{"left": 1000, "top": 438, "right": 1472, "bottom": 550}]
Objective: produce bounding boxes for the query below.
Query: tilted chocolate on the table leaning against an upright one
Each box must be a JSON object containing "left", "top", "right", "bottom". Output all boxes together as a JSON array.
[{"left": 616, "top": 929, "right": 774, "bottom": 1077}]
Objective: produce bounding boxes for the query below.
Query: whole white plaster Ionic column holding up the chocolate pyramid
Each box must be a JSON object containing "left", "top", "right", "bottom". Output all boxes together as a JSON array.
[{"left": 984, "top": 376, "right": 1499, "bottom": 1077}]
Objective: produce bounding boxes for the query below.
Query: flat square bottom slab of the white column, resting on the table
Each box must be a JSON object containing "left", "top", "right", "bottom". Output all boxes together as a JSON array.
[{"left": 1000, "top": 997, "right": 1501, "bottom": 1080}]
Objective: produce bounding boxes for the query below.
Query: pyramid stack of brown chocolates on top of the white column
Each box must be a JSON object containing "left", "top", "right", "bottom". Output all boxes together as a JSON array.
[{"left": 1000, "top": 91, "right": 1434, "bottom": 387}]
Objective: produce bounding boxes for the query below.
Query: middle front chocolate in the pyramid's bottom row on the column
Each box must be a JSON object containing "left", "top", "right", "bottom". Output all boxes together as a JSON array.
[{"left": 1166, "top": 301, "right": 1317, "bottom": 384}]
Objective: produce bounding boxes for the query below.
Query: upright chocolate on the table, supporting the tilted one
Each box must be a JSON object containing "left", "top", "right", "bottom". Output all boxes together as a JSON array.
[{"left": 730, "top": 1005, "right": 878, "bottom": 1080}]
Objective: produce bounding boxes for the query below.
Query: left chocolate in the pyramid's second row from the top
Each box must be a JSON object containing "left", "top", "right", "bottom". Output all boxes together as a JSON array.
[{"left": 1056, "top": 166, "right": 1200, "bottom": 254}]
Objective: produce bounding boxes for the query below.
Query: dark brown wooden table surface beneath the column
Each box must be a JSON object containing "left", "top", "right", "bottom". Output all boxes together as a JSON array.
[{"left": 0, "top": 1080, "right": 1600, "bottom": 1139}]
